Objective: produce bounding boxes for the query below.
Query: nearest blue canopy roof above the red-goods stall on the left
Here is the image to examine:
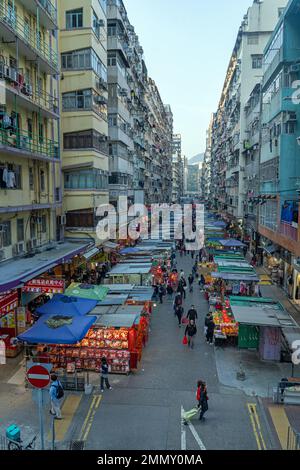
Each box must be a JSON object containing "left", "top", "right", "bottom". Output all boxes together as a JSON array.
[{"left": 18, "top": 314, "right": 97, "bottom": 344}]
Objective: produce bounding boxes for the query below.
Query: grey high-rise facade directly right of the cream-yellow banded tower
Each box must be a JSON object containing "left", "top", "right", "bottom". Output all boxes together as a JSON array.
[{"left": 107, "top": 0, "right": 173, "bottom": 205}]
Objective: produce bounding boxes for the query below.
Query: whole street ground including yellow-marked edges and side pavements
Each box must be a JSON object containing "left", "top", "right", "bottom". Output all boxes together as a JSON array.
[{"left": 0, "top": 248, "right": 299, "bottom": 450}]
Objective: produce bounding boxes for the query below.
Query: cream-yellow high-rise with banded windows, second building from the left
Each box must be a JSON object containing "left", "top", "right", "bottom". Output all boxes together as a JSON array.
[{"left": 59, "top": 0, "right": 109, "bottom": 244}]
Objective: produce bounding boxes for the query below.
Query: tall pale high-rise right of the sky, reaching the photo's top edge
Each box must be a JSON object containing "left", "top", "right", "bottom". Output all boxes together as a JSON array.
[{"left": 212, "top": 0, "right": 287, "bottom": 222}]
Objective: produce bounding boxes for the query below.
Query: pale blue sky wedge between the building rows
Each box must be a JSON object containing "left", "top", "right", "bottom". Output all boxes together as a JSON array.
[{"left": 124, "top": 0, "right": 253, "bottom": 158}]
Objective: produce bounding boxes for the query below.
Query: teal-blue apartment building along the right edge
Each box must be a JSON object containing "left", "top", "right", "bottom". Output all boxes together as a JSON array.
[{"left": 258, "top": 0, "right": 300, "bottom": 303}]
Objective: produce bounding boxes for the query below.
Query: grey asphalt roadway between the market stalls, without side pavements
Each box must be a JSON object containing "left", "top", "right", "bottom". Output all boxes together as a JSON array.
[{"left": 63, "top": 252, "right": 270, "bottom": 450}]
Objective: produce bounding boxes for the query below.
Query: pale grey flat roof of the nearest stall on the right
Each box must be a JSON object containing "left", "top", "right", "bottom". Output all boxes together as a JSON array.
[{"left": 231, "top": 304, "right": 297, "bottom": 328}]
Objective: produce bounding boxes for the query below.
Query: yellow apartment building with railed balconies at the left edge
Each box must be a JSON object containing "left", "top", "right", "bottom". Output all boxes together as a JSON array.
[{"left": 0, "top": 0, "right": 63, "bottom": 264}]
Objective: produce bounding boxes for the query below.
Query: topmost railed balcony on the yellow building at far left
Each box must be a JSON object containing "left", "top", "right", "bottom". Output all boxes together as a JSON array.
[{"left": 0, "top": 3, "right": 58, "bottom": 74}]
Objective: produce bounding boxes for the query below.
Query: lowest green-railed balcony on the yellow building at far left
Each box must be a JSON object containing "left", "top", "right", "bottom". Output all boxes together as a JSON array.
[{"left": 0, "top": 124, "right": 60, "bottom": 161}]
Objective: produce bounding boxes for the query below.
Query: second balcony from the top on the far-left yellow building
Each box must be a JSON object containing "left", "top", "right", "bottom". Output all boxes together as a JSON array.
[{"left": 0, "top": 63, "right": 59, "bottom": 119}]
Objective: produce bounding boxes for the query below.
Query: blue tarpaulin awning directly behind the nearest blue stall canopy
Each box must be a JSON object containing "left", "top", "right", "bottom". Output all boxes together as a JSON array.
[{"left": 36, "top": 294, "right": 97, "bottom": 315}]
